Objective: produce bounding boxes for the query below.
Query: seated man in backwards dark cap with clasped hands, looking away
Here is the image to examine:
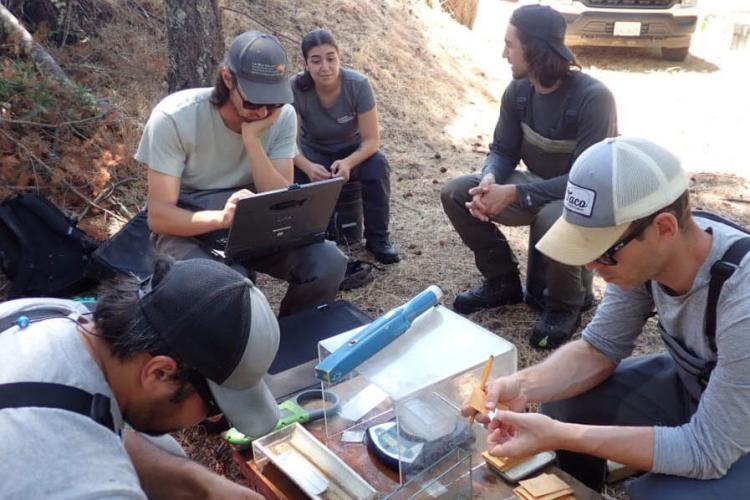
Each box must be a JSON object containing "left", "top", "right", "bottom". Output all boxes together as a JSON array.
[{"left": 441, "top": 5, "right": 617, "bottom": 349}]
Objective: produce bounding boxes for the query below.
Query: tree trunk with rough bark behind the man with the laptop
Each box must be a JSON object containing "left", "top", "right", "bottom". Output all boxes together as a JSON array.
[{"left": 165, "top": 0, "right": 224, "bottom": 94}]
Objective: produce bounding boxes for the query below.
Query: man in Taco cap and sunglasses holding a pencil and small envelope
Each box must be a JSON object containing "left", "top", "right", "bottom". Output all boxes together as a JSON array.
[{"left": 464, "top": 137, "right": 750, "bottom": 500}]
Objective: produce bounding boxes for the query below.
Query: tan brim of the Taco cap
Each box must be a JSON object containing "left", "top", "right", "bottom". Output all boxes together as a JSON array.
[{"left": 536, "top": 217, "right": 630, "bottom": 266}]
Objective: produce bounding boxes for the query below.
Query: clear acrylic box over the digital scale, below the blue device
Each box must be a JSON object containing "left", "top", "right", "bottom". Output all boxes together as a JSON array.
[{"left": 318, "top": 306, "right": 517, "bottom": 498}]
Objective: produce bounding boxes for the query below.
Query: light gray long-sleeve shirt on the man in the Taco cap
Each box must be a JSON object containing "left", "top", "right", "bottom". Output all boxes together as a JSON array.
[{"left": 583, "top": 218, "right": 750, "bottom": 479}]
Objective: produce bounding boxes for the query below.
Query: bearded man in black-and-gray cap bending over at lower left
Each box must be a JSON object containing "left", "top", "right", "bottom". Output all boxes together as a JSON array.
[{"left": 0, "top": 258, "right": 279, "bottom": 499}]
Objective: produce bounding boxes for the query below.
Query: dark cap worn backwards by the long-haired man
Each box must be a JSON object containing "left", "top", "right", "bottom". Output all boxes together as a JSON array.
[{"left": 510, "top": 4, "right": 576, "bottom": 62}]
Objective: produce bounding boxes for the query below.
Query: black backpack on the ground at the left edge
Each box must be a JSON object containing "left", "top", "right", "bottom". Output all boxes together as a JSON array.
[{"left": 0, "top": 193, "right": 97, "bottom": 299}]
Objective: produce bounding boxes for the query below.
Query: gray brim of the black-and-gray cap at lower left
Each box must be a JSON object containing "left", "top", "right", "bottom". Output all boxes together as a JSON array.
[{"left": 207, "top": 379, "right": 281, "bottom": 438}]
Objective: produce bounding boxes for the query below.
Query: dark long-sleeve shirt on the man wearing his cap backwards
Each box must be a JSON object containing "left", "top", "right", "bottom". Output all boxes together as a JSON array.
[{"left": 482, "top": 72, "right": 617, "bottom": 208}]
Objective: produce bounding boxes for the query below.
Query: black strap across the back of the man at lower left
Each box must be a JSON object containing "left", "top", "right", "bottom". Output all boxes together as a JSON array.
[{"left": 0, "top": 382, "right": 117, "bottom": 433}]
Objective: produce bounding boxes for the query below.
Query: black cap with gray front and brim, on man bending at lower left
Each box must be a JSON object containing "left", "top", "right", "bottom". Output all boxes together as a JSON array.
[{"left": 140, "top": 259, "right": 279, "bottom": 437}]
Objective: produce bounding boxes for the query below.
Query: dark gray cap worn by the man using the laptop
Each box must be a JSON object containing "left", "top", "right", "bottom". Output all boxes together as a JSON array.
[{"left": 226, "top": 31, "right": 294, "bottom": 104}]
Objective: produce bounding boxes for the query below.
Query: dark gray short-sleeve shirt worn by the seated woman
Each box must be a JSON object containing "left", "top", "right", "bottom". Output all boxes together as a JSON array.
[{"left": 291, "top": 69, "right": 375, "bottom": 153}]
